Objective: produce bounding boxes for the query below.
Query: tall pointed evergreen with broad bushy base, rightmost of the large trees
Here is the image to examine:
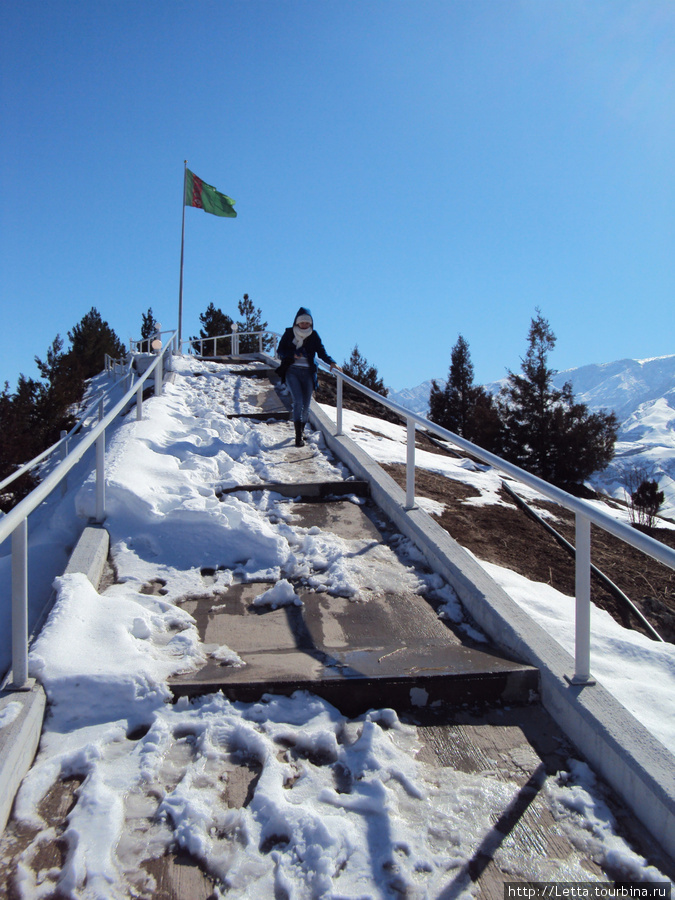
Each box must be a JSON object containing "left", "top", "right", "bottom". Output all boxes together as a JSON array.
[{"left": 498, "top": 310, "right": 617, "bottom": 485}]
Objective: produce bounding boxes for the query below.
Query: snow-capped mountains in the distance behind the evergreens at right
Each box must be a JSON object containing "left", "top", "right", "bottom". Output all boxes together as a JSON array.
[{"left": 389, "top": 355, "right": 675, "bottom": 518}]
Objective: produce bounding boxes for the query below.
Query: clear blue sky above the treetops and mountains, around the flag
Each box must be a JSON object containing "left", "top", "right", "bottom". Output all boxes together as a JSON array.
[{"left": 0, "top": 0, "right": 675, "bottom": 389}]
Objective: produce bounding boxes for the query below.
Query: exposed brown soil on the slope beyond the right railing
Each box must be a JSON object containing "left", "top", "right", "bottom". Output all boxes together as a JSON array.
[{"left": 317, "top": 374, "right": 675, "bottom": 642}]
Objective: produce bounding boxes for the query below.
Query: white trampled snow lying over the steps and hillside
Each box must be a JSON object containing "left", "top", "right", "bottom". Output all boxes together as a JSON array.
[{"left": 0, "top": 359, "right": 675, "bottom": 900}]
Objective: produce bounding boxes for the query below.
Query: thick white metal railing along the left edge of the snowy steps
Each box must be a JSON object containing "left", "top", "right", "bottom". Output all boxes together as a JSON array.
[{"left": 0, "top": 332, "right": 177, "bottom": 690}]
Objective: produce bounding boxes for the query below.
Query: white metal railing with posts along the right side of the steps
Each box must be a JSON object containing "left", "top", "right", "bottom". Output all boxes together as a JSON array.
[{"left": 320, "top": 363, "right": 675, "bottom": 684}]
